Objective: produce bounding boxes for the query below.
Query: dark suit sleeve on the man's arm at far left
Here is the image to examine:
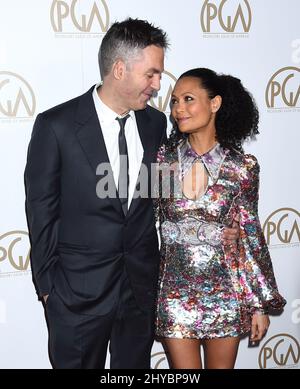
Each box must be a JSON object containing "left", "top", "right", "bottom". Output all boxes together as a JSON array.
[{"left": 25, "top": 115, "right": 60, "bottom": 296}]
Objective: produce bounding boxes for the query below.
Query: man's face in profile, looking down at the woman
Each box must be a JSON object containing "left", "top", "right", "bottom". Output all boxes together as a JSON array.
[{"left": 123, "top": 45, "right": 164, "bottom": 111}]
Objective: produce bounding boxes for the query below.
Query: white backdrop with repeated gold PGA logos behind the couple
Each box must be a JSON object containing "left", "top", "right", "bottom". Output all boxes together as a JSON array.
[{"left": 0, "top": 0, "right": 300, "bottom": 369}]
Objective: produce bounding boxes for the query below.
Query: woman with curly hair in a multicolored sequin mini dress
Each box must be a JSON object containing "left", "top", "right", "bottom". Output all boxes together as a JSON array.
[{"left": 156, "top": 68, "right": 285, "bottom": 369}]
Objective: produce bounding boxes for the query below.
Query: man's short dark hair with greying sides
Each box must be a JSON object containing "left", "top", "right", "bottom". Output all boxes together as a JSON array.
[{"left": 98, "top": 18, "right": 169, "bottom": 79}]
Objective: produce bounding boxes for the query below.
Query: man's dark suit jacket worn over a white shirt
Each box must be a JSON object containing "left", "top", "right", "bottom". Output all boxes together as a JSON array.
[{"left": 25, "top": 87, "right": 166, "bottom": 315}]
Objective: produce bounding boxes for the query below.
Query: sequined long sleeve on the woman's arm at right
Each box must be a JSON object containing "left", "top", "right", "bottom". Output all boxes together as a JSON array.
[{"left": 234, "top": 155, "right": 286, "bottom": 310}]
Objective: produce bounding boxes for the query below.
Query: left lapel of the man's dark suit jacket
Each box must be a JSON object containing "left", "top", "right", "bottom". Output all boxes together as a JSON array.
[{"left": 75, "top": 87, "right": 123, "bottom": 214}]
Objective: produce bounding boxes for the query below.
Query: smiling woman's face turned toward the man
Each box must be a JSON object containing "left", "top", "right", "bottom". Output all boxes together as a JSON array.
[{"left": 171, "top": 77, "right": 221, "bottom": 134}]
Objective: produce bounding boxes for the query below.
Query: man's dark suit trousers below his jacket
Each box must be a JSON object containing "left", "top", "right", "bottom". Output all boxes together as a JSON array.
[{"left": 46, "top": 275, "right": 154, "bottom": 369}]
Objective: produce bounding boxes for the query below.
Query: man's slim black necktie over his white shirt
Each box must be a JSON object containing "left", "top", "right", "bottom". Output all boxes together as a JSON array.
[{"left": 116, "top": 115, "right": 129, "bottom": 215}]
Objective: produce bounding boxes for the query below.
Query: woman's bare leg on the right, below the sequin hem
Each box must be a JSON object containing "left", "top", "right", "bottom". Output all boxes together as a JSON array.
[{"left": 202, "top": 337, "right": 240, "bottom": 369}]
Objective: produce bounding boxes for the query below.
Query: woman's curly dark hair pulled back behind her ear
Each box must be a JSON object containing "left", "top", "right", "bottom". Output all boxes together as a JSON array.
[{"left": 166, "top": 68, "right": 259, "bottom": 152}]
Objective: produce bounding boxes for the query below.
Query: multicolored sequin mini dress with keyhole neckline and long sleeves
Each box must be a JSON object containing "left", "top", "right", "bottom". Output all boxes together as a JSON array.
[{"left": 156, "top": 140, "right": 285, "bottom": 339}]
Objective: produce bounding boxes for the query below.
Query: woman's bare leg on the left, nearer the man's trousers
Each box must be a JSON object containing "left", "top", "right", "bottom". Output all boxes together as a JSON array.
[{"left": 163, "top": 338, "right": 202, "bottom": 369}]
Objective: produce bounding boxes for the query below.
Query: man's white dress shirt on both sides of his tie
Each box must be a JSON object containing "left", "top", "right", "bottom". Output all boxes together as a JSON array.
[{"left": 93, "top": 84, "right": 144, "bottom": 208}]
